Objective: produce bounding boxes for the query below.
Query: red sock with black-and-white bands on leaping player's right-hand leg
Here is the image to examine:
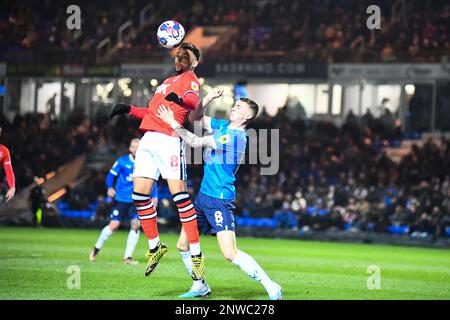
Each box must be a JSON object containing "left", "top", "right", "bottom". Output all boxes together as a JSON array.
[{"left": 173, "top": 191, "right": 200, "bottom": 244}]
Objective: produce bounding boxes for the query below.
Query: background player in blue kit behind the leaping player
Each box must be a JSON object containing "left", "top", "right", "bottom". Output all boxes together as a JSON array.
[{"left": 89, "top": 139, "right": 158, "bottom": 264}]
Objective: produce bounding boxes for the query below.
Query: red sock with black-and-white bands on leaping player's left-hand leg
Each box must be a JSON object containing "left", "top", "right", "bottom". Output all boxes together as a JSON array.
[{"left": 133, "top": 192, "right": 158, "bottom": 240}]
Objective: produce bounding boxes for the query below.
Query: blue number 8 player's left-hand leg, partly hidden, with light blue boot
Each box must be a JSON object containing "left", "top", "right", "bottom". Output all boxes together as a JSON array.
[{"left": 177, "top": 228, "right": 211, "bottom": 298}]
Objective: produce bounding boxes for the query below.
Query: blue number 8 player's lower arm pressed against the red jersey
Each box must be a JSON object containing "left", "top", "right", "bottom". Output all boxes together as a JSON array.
[{"left": 157, "top": 105, "right": 217, "bottom": 149}]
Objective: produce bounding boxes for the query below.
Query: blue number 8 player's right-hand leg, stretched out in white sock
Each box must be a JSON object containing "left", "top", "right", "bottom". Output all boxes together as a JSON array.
[{"left": 217, "top": 231, "right": 283, "bottom": 300}]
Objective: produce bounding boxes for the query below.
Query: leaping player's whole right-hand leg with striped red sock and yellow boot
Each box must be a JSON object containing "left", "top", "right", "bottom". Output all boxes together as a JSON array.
[{"left": 167, "top": 179, "right": 205, "bottom": 280}]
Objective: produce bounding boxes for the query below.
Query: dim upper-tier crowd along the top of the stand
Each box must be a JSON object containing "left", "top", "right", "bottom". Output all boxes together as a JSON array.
[{"left": 0, "top": 0, "right": 450, "bottom": 63}]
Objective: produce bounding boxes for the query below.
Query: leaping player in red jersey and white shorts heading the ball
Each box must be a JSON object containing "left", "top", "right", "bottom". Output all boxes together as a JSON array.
[{"left": 111, "top": 43, "right": 205, "bottom": 280}]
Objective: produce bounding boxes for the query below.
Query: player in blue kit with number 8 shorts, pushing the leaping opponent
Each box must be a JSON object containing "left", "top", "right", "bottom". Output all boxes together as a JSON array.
[{"left": 158, "top": 90, "right": 282, "bottom": 300}]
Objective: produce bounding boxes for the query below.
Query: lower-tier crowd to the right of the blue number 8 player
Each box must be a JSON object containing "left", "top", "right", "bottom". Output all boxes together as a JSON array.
[{"left": 232, "top": 105, "right": 450, "bottom": 237}]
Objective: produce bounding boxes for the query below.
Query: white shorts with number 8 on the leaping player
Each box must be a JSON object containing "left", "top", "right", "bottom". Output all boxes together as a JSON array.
[{"left": 133, "top": 131, "right": 187, "bottom": 181}]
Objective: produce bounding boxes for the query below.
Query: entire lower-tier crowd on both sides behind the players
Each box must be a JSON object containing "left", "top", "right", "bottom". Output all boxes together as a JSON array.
[{"left": 0, "top": 99, "right": 450, "bottom": 237}]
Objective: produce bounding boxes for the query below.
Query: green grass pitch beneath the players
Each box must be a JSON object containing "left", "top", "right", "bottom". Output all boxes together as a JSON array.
[{"left": 0, "top": 228, "right": 450, "bottom": 300}]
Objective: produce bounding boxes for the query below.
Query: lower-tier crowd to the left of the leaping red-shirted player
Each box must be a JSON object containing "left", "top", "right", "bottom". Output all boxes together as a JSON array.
[{"left": 0, "top": 111, "right": 139, "bottom": 190}]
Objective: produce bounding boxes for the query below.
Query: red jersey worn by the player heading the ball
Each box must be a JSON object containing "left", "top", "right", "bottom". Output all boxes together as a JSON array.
[{"left": 130, "top": 71, "right": 200, "bottom": 136}]
